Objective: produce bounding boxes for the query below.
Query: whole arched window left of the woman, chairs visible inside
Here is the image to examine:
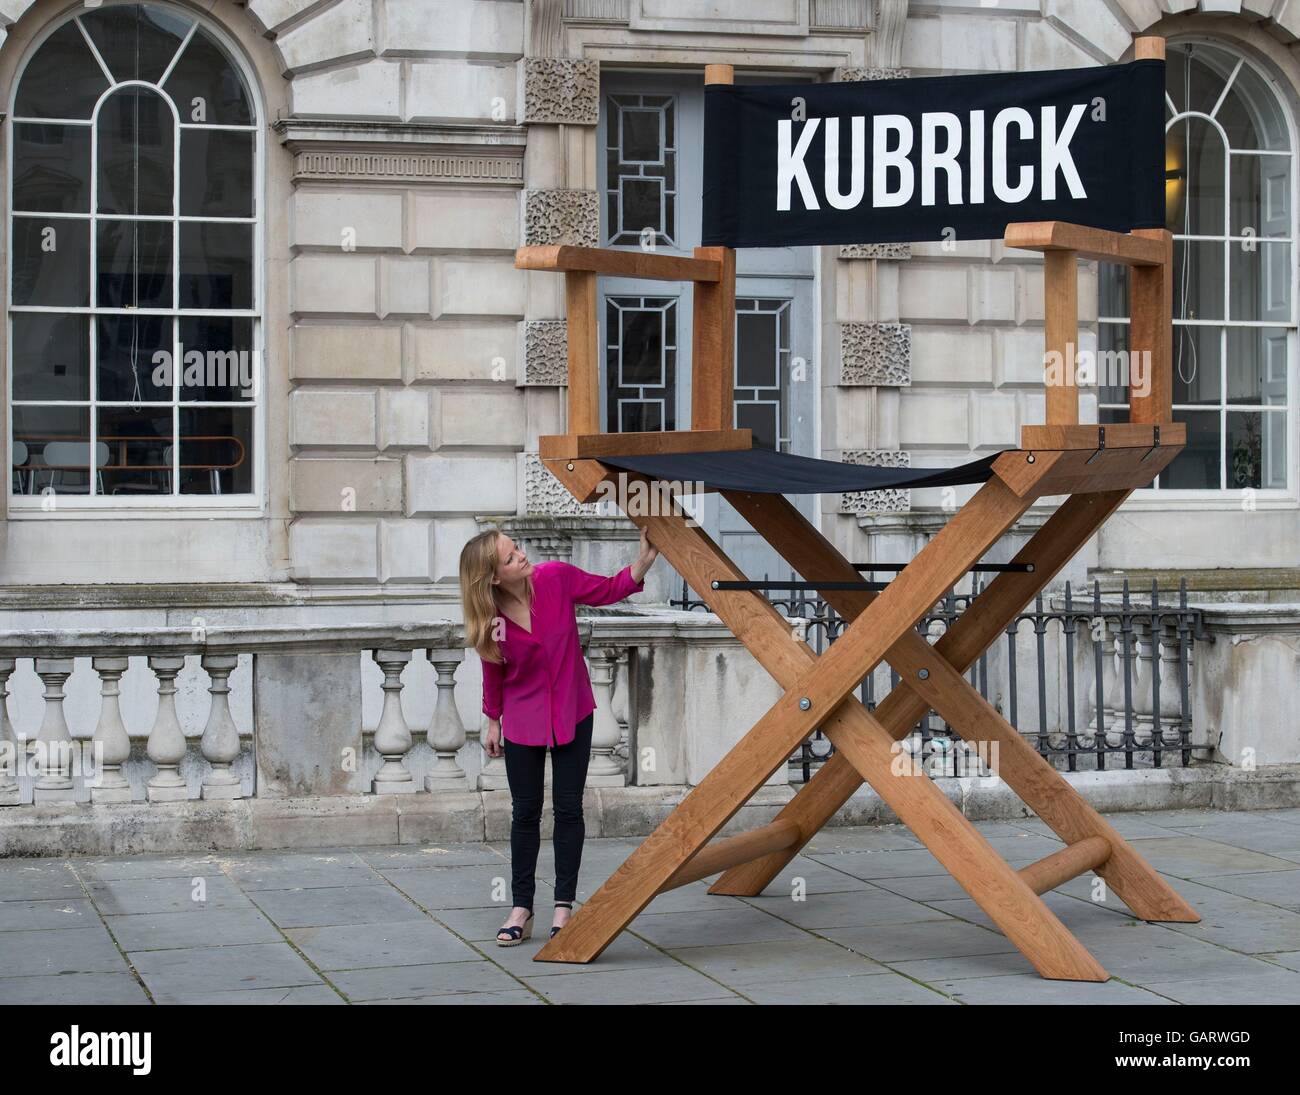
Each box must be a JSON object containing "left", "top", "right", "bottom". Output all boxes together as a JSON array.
[{"left": 8, "top": 4, "right": 261, "bottom": 499}]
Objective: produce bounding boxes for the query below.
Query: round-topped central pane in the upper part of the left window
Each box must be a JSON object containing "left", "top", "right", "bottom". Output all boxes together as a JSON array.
[{"left": 96, "top": 87, "right": 176, "bottom": 216}]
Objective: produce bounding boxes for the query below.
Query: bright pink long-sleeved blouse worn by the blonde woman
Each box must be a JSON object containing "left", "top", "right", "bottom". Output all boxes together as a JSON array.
[{"left": 482, "top": 559, "right": 645, "bottom": 745}]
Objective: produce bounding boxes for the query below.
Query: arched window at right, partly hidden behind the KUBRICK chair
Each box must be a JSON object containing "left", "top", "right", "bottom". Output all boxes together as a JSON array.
[{"left": 1100, "top": 42, "right": 1296, "bottom": 490}]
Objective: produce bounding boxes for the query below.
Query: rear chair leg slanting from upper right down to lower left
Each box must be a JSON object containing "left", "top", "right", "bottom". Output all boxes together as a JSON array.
[{"left": 709, "top": 490, "right": 1128, "bottom": 896}]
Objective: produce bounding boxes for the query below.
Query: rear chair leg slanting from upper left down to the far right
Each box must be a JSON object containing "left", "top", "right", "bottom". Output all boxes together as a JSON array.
[{"left": 729, "top": 486, "right": 1200, "bottom": 923}]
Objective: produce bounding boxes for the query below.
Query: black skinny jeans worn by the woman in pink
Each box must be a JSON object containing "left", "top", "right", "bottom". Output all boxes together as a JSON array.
[{"left": 503, "top": 711, "right": 595, "bottom": 909}]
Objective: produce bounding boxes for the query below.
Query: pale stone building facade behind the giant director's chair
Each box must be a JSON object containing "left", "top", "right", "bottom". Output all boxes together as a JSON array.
[{"left": 0, "top": 0, "right": 1300, "bottom": 785}]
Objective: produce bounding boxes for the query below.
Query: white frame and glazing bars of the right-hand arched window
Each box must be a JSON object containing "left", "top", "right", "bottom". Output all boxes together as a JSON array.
[{"left": 1097, "top": 36, "right": 1300, "bottom": 510}]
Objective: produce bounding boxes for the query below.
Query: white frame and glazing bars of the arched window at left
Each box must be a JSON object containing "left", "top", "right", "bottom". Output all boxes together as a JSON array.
[{"left": 4, "top": 0, "right": 268, "bottom": 520}]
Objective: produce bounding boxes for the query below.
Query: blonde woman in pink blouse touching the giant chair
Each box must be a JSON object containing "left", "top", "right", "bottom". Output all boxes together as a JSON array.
[{"left": 460, "top": 528, "right": 659, "bottom": 947}]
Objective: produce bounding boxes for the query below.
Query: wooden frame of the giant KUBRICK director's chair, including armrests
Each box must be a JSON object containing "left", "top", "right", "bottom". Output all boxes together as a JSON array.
[{"left": 516, "top": 39, "right": 1200, "bottom": 981}]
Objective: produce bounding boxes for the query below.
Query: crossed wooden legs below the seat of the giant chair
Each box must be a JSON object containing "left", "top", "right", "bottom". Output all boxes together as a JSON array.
[{"left": 536, "top": 445, "right": 1200, "bottom": 981}]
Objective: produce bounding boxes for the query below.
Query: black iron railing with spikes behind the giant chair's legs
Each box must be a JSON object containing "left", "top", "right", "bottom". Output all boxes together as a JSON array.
[{"left": 670, "top": 572, "right": 1205, "bottom": 782}]
